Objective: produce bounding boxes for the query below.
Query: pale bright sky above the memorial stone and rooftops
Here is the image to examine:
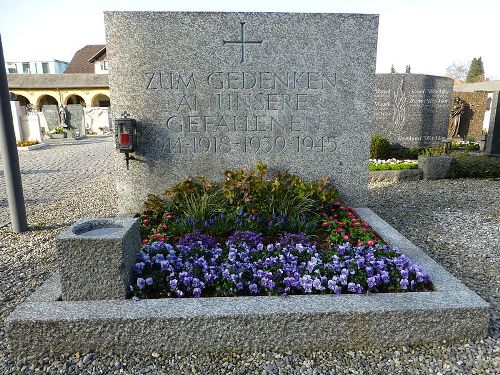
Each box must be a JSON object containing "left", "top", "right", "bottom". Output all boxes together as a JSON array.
[{"left": 0, "top": 0, "right": 500, "bottom": 79}]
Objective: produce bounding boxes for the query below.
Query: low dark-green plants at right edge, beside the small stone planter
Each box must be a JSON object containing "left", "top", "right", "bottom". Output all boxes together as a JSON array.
[{"left": 448, "top": 153, "right": 500, "bottom": 178}]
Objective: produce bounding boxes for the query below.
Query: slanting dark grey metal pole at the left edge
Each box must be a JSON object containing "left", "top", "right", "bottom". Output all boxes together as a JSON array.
[{"left": 0, "top": 35, "right": 28, "bottom": 233}]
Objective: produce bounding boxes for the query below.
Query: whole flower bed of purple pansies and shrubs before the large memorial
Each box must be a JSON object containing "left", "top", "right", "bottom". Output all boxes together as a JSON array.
[{"left": 130, "top": 164, "right": 431, "bottom": 299}]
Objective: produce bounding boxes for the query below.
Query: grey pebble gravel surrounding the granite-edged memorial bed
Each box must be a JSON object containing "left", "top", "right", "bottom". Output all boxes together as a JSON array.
[{"left": 0, "top": 173, "right": 500, "bottom": 374}]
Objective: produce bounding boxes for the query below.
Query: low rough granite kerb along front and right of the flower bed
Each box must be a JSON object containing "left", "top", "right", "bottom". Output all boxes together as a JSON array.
[{"left": 6, "top": 208, "right": 489, "bottom": 353}]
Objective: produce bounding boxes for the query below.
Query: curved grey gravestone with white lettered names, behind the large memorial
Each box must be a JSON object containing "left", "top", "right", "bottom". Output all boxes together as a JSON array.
[{"left": 373, "top": 73, "right": 453, "bottom": 147}]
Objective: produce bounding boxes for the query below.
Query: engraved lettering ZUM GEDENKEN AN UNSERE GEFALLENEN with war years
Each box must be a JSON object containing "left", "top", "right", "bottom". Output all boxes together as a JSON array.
[{"left": 144, "top": 71, "right": 337, "bottom": 155}]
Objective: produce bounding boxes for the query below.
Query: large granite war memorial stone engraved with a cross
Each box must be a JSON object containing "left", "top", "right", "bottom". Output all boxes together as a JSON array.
[{"left": 105, "top": 12, "right": 378, "bottom": 213}]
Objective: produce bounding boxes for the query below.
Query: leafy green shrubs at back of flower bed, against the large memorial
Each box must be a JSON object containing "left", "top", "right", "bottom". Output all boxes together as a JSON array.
[{"left": 141, "top": 162, "right": 338, "bottom": 240}]
